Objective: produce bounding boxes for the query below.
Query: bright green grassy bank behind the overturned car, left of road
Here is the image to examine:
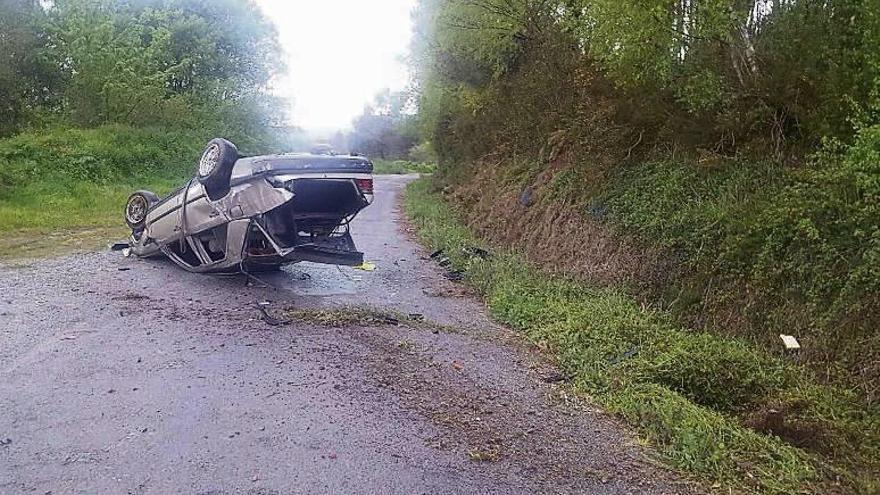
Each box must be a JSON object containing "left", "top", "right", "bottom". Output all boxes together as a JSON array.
[{"left": 0, "top": 126, "right": 204, "bottom": 258}]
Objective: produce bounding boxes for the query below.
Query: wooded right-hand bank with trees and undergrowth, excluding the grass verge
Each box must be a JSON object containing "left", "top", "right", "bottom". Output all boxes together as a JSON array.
[{"left": 414, "top": 0, "right": 880, "bottom": 409}]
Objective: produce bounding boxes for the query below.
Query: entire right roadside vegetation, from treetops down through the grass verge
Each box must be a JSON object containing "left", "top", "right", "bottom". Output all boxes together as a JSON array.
[{"left": 413, "top": 0, "right": 880, "bottom": 492}]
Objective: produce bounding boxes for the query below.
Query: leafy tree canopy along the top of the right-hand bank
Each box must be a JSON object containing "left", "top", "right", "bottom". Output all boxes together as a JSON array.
[{"left": 413, "top": 0, "right": 878, "bottom": 161}]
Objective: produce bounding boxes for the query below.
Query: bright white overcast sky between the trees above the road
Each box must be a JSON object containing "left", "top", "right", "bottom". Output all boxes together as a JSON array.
[{"left": 256, "top": 0, "right": 416, "bottom": 133}]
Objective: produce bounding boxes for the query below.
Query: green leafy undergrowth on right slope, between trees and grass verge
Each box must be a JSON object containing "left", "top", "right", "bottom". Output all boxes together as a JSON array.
[{"left": 588, "top": 141, "right": 880, "bottom": 398}]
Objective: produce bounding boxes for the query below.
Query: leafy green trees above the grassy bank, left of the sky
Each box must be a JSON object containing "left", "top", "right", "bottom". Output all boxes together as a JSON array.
[{"left": 0, "top": 0, "right": 281, "bottom": 138}]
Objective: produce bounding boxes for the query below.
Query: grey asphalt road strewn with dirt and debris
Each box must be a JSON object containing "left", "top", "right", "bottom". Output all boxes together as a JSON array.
[{"left": 0, "top": 176, "right": 692, "bottom": 495}]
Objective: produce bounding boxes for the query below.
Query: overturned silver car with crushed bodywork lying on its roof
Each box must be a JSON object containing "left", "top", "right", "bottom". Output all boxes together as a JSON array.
[{"left": 125, "top": 139, "right": 373, "bottom": 273}]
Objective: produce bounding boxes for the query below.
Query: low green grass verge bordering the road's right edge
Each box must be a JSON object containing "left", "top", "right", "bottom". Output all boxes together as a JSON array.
[{"left": 405, "top": 179, "right": 880, "bottom": 494}]
